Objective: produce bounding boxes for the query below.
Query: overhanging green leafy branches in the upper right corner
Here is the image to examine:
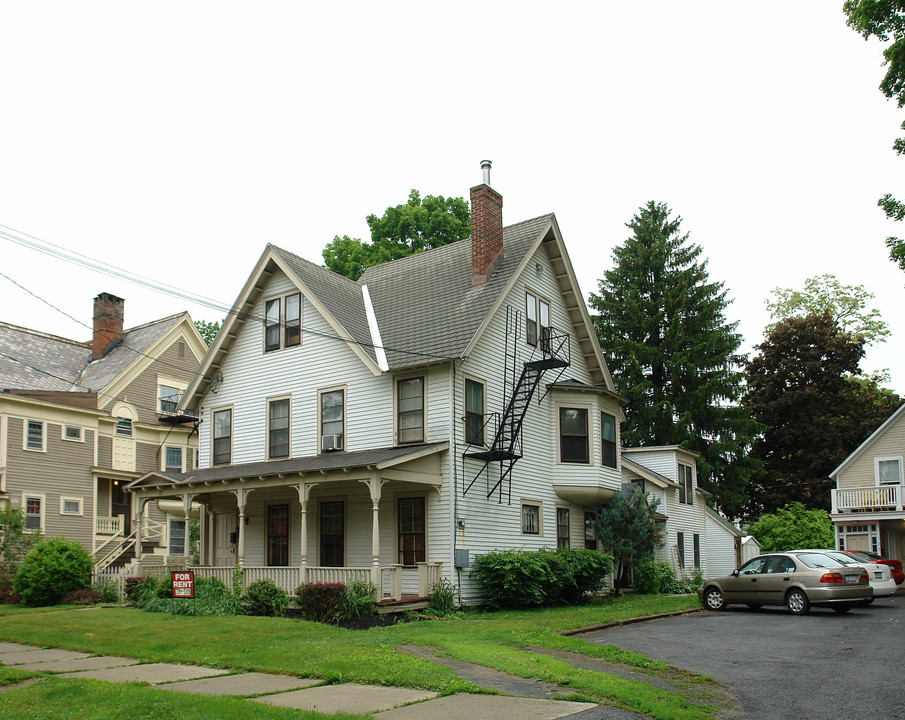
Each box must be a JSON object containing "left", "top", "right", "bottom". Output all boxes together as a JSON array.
[{"left": 842, "top": 0, "right": 905, "bottom": 270}]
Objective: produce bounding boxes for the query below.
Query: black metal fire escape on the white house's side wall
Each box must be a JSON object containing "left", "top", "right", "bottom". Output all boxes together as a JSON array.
[{"left": 462, "top": 307, "right": 571, "bottom": 504}]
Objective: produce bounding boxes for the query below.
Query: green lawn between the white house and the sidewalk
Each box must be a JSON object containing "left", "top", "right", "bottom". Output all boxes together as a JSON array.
[{"left": 0, "top": 596, "right": 716, "bottom": 720}]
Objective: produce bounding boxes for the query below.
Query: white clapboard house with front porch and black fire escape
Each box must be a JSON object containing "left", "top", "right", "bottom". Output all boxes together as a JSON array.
[{"left": 130, "top": 163, "right": 632, "bottom": 601}]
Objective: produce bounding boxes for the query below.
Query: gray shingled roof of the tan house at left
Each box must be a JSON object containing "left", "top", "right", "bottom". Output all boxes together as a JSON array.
[{"left": 0, "top": 313, "right": 183, "bottom": 392}]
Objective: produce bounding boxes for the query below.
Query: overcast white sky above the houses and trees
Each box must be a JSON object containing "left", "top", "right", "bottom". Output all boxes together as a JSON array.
[{"left": 0, "top": 0, "right": 905, "bottom": 393}]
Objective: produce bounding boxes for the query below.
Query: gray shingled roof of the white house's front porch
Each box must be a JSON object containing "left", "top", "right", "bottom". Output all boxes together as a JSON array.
[{"left": 130, "top": 441, "right": 449, "bottom": 487}]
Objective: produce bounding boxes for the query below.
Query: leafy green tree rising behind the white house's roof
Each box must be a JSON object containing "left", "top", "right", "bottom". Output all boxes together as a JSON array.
[{"left": 323, "top": 190, "right": 471, "bottom": 280}]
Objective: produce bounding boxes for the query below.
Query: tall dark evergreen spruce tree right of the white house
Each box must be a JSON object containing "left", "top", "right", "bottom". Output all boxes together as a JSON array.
[{"left": 590, "top": 201, "right": 758, "bottom": 517}]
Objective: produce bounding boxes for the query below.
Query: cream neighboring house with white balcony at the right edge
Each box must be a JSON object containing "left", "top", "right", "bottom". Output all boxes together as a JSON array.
[{"left": 830, "top": 405, "right": 905, "bottom": 561}]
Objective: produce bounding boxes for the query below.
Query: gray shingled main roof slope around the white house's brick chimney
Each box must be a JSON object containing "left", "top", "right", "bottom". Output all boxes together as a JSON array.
[{"left": 358, "top": 215, "right": 553, "bottom": 369}]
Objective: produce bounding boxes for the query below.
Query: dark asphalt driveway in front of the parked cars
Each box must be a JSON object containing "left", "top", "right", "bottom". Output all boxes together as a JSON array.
[{"left": 582, "top": 595, "right": 905, "bottom": 720}]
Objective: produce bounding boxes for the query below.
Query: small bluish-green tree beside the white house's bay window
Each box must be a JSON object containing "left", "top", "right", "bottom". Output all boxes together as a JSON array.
[{"left": 596, "top": 487, "right": 663, "bottom": 595}]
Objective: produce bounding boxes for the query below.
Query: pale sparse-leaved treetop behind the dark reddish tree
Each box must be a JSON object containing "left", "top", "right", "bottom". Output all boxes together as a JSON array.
[{"left": 766, "top": 274, "right": 890, "bottom": 345}]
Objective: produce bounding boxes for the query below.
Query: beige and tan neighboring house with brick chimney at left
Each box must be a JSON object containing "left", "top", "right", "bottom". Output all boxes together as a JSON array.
[{"left": 0, "top": 293, "right": 206, "bottom": 569}]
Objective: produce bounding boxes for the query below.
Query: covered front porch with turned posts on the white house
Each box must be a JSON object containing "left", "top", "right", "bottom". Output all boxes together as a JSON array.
[{"left": 128, "top": 443, "right": 448, "bottom": 601}]
